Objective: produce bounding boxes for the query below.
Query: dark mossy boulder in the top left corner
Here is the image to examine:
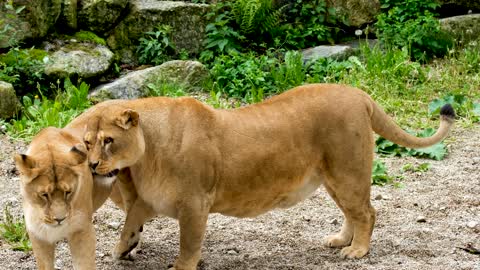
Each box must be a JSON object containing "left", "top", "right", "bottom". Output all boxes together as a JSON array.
[{"left": 0, "top": 0, "right": 63, "bottom": 48}]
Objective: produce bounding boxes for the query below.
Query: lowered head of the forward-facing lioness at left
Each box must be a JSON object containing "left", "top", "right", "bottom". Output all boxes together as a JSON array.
[{"left": 15, "top": 128, "right": 92, "bottom": 227}]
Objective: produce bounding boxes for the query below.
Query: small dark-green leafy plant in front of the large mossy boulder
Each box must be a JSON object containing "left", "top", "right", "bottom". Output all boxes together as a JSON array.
[{"left": 137, "top": 25, "right": 176, "bottom": 65}]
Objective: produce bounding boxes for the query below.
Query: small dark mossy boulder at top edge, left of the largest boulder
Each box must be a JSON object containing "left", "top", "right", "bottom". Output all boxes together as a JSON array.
[{"left": 78, "top": 0, "right": 129, "bottom": 34}]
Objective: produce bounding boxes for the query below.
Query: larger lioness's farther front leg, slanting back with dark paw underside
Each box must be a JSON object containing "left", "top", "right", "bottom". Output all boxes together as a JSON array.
[{"left": 113, "top": 198, "right": 156, "bottom": 259}]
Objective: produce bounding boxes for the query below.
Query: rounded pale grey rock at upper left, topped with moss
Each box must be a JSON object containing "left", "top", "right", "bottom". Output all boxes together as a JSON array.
[{"left": 45, "top": 43, "right": 113, "bottom": 78}]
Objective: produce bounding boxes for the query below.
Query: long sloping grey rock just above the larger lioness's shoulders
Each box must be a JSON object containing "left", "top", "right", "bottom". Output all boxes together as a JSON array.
[{"left": 90, "top": 60, "right": 208, "bottom": 102}]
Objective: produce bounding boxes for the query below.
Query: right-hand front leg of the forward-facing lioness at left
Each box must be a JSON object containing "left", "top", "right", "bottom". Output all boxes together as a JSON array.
[{"left": 68, "top": 224, "right": 96, "bottom": 270}]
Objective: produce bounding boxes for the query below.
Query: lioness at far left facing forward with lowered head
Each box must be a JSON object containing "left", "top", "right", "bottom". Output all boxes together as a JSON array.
[{"left": 15, "top": 123, "right": 132, "bottom": 270}]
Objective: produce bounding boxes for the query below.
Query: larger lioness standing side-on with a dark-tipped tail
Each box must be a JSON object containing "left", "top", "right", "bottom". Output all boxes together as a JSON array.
[{"left": 84, "top": 84, "right": 454, "bottom": 270}]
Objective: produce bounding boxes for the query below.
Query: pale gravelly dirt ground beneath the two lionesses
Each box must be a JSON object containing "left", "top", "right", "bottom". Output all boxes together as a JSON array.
[{"left": 0, "top": 125, "right": 480, "bottom": 270}]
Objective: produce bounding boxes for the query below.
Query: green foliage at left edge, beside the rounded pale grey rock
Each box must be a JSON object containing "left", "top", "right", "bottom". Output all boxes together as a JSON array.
[{"left": 0, "top": 48, "right": 47, "bottom": 95}]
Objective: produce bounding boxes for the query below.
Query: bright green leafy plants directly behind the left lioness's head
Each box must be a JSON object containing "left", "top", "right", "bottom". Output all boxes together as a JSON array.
[{"left": 6, "top": 79, "right": 91, "bottom": 140}]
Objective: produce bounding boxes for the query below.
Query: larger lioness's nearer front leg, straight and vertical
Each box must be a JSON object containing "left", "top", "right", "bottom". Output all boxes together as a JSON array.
[{"left": 170, "top": 202, "right": 208, "bottom": 270}]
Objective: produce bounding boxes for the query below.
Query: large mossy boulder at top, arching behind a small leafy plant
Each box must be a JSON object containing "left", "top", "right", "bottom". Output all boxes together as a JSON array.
[{"left": 107, "top": 0, "right": 209, "bottom": 63}]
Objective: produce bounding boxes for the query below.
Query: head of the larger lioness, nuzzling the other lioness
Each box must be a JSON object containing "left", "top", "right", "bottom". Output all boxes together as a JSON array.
[{"left": 83, "top": 106, "right": 145, "bottom": 177}]
